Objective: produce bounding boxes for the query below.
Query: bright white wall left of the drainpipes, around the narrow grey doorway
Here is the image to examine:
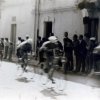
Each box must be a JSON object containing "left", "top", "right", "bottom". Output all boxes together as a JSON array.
[{"left": 0, "top": 0, "right": 34, "bottom": 38}]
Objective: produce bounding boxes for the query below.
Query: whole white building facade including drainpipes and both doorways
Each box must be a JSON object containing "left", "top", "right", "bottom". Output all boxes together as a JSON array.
[{"left": 0, "top": 0, "right": 84, "bottom": 50}]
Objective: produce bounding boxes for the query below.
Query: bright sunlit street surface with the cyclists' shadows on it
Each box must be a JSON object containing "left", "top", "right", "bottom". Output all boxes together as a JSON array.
[{"left": 0, "top": 62, "right": 100, "bottom": 100}]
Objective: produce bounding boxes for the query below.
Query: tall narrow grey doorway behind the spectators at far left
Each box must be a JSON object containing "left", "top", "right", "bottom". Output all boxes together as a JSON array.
[{"left": 10, "top": 24, "right": 17, "bottom": 51}]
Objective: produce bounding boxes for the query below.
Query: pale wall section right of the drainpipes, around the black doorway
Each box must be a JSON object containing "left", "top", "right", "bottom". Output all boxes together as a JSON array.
[{"left": 39, "top": 0, "right": 84, "bottom": 42}]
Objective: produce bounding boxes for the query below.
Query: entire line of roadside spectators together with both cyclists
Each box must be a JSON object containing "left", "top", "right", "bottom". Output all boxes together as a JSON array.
[{"left": 0, "top": 32, "right": 97, "bottom": 81}]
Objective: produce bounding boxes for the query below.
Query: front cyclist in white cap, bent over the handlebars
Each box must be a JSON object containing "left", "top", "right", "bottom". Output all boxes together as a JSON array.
[{"left": 39, "top": 36, "right": 58, "bottom": 83}]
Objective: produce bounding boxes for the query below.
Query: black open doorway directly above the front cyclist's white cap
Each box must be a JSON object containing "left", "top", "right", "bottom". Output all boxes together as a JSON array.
[{"left": 44, "top": 22, "right": 52, "bottom": 38}]
